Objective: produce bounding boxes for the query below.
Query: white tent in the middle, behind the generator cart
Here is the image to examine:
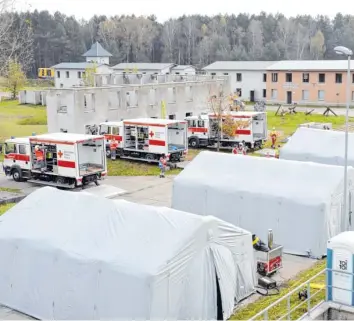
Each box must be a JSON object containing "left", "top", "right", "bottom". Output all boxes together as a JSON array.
[{"left": 172, "top": 152, "right": 354, "bottom": 257}]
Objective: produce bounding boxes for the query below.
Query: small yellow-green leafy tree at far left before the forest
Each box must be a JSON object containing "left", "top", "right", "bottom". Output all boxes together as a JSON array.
[{"left": 6, "top": 59, "right": 26, "bottom": 99}]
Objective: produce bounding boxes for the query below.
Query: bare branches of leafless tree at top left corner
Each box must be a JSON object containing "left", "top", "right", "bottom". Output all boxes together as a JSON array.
[{"left": 0, "top": 0, "right": 33, "bottom": 75}]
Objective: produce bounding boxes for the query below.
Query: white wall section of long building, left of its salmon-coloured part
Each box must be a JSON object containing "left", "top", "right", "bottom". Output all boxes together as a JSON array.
[{"left": 203, "top": 70, "right": 266, "bottom": 101}]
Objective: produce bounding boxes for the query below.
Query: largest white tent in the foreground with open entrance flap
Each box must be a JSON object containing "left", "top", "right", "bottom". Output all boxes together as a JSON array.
[{"left": 0, "top": 187, "right": 255, "bottom": 320}]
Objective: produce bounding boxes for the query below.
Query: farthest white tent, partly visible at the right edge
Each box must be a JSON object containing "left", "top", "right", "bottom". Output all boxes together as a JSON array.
[{"left": 279, "top": 127, "right": 354, "bottom": 166}]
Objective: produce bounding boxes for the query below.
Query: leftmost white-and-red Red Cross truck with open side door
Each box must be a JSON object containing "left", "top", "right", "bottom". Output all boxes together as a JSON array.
[{"left": 3, "top": 133, "right": 107, "bottom": 188}]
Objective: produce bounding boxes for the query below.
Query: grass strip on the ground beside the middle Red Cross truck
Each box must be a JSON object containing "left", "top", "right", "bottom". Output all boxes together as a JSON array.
[{"left": 107, "top": 159, "right": 181, "bottom": 176}]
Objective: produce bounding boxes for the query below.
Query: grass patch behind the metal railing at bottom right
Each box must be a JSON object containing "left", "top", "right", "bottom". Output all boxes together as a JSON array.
[{"left": 230, "top": 260, "right": 326, "bottom": 320}]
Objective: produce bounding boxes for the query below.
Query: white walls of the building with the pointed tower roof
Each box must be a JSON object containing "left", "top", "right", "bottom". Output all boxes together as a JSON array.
[{"left": 54, "top": 65, "right": 111, "bottom": 89}]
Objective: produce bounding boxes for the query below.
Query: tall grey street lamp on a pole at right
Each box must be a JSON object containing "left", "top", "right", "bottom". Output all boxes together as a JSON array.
[{"left": 334, "top": 46, "right": 353, "bottom": 227}]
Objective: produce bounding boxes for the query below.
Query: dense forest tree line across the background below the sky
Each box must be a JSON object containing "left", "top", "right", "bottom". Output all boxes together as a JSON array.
[{"left": 0, "top": 7, "right": 354, "bottom": 77}]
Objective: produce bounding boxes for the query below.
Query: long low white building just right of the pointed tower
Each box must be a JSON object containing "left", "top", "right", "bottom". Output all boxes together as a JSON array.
[{"left": 112, "top": 62, "right": 175, "bottom": 75}]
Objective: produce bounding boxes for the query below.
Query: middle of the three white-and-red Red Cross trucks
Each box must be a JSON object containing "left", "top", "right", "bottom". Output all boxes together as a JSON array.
[{"left": 99, "top": 118, "right": 188, "bottom": 163}]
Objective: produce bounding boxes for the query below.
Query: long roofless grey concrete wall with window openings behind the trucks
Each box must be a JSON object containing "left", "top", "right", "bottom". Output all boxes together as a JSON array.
[{"left": 47, "top": 79, "right": 229, "bottom": 133}]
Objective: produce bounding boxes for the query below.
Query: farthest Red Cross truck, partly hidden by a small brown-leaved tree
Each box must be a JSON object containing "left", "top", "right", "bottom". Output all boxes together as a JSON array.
[{"left": 186, "top": 112, "right": 268, "bottom": 150}]
